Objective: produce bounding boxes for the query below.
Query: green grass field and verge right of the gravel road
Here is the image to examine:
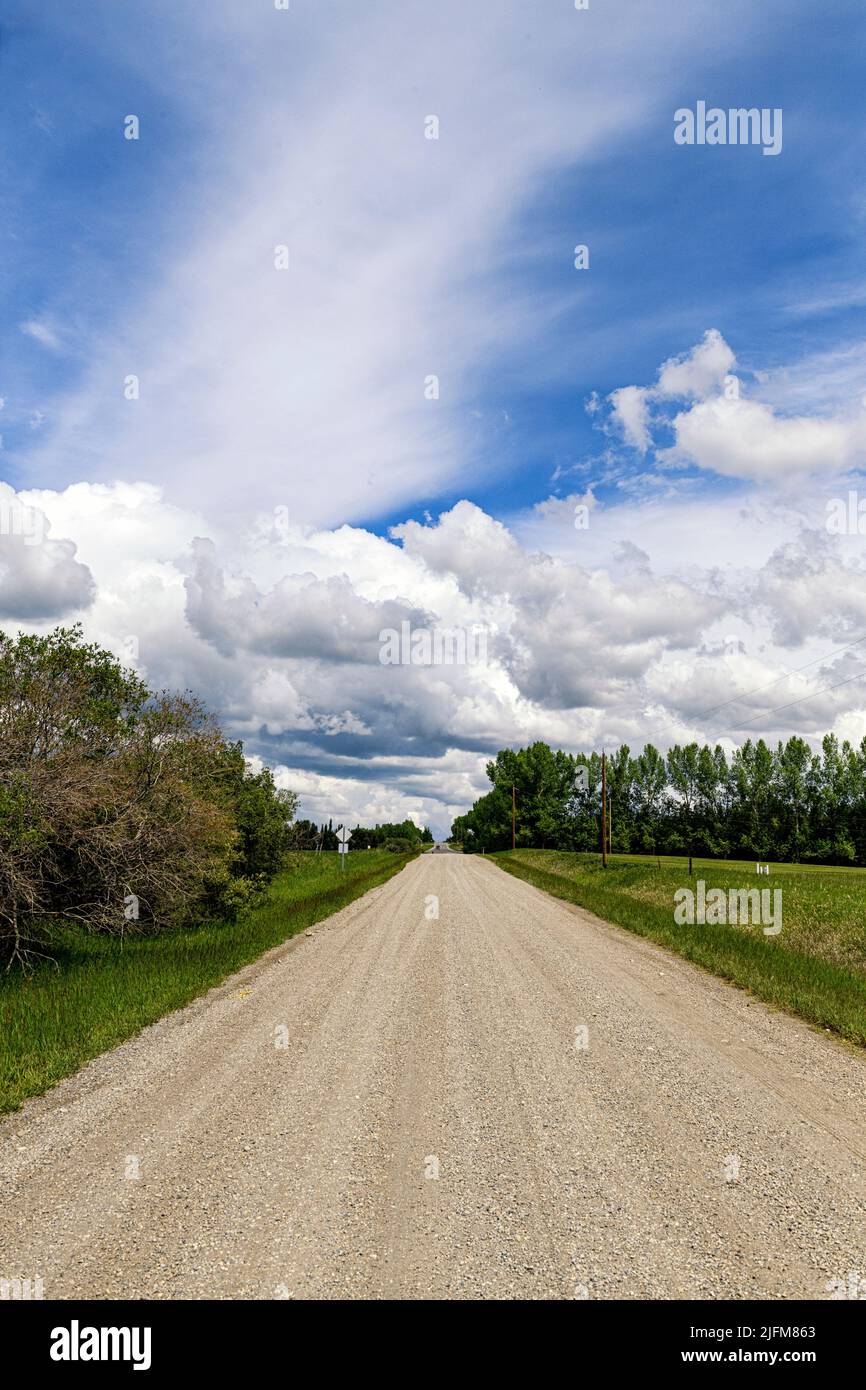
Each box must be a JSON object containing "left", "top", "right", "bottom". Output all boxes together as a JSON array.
[{"left": 489, "top": 849, "right": 866, "bottom": 1047}]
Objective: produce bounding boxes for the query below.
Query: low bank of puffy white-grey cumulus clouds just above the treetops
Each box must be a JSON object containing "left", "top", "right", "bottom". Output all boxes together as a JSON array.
[{"left": 3, "top": 484, "right": 866, "bottom": 834}]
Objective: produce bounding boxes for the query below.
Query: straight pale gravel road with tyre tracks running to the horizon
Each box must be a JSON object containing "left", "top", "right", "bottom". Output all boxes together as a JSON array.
[{"left": 0, "top": 853, "right": 866, "bottom": 1298}]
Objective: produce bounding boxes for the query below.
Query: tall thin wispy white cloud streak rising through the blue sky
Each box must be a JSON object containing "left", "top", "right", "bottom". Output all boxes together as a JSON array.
[{"left": 20, "top": 0, "right": 748, "bottom": 525}]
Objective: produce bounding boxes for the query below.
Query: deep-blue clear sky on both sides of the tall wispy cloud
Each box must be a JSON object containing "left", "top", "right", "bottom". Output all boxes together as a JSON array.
[{"left": 3, "top": 3, "right": 866, "bottom": 528}]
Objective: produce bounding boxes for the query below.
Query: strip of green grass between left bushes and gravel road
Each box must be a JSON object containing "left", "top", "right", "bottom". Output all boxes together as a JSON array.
[{"left": 0, "top": 849, "right": 414, "bottom": 1113}]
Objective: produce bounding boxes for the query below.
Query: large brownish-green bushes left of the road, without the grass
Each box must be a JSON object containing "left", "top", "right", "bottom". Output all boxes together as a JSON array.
[{"left": 0, "top": 627, "right": 297, "bottom": 960}]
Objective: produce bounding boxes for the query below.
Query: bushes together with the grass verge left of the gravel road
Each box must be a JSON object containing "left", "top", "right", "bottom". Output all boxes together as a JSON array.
[{"left": 0, "top": 627, "right": 432, "bottom": 1109}]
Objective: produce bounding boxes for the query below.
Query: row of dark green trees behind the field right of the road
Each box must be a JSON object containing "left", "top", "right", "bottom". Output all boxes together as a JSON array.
[{"left": 452, "top": 734, "right": 866, "bottom": 865}]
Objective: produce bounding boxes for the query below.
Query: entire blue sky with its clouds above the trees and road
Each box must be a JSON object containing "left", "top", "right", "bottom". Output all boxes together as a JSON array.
[{"left": 0, "top": 0, "right": 866, "bottom": 828}]
